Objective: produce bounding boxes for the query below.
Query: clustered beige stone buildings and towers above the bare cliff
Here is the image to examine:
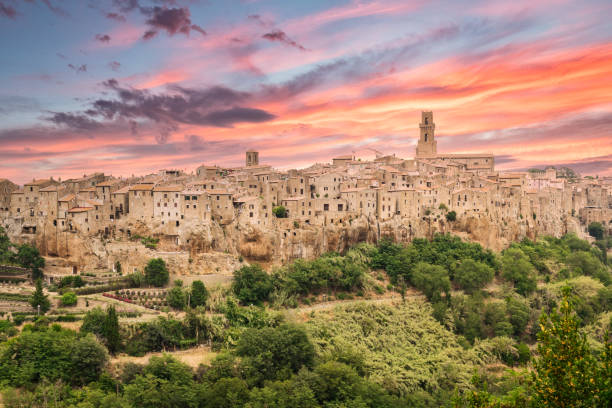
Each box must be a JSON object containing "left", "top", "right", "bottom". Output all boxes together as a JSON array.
[{"left": 0, "top": 112, "right": 612, "bottom": 262}]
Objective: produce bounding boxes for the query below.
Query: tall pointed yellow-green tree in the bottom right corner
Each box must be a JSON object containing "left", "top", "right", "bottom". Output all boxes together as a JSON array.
[{"left": 533, "top": 288, "right": 610, "bottom": 408}]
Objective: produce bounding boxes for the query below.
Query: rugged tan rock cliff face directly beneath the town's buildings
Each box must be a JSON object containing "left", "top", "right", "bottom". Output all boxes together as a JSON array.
[{"left": 7, "top": 212, "right": 582, "bottom": 275}]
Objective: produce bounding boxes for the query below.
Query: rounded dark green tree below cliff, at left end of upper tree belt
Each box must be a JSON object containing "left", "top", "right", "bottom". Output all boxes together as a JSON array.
[{"left": 232, "top": 265, "right": 274, "bottom": 305}]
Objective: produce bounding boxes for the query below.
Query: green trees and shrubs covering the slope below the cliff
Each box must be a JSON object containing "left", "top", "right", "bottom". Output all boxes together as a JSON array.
[{"left": 0, "top": 231, "right": 612, "bottom": 408}]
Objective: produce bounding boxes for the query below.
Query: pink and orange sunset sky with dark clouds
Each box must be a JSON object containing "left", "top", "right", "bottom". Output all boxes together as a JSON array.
[{"left": 0, "top": 0, "right": 612, "bottom": 184}]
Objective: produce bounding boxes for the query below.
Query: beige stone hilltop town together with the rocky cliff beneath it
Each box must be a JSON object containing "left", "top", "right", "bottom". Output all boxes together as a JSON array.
[{"left": 0, "top": 112, "right": 612, "bottom": 273}]
